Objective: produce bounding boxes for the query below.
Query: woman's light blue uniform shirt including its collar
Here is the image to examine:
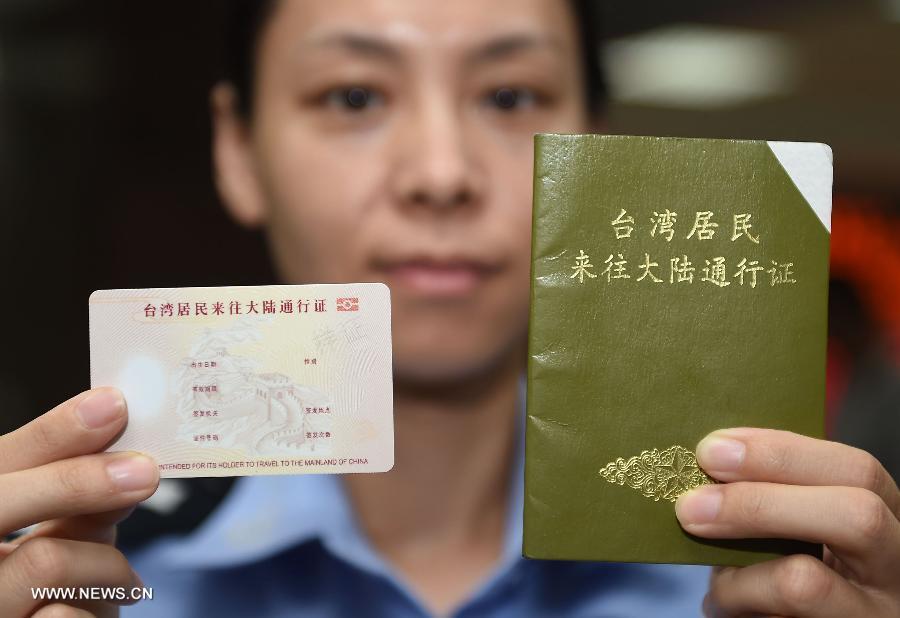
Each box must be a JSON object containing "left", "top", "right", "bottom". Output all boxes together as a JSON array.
[{"left": 123, "top": 402, "right": 709, "bottom": 618}]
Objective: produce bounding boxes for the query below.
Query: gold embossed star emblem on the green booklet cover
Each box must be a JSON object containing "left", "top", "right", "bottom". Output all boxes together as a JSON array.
[{"left": 600, "top": 445, "right": 715, "bottom": 502}]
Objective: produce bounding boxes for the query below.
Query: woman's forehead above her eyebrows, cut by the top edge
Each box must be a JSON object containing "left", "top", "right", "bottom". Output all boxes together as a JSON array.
[{"left": 263, "top": 0, "right": 575, "bottom": 53}]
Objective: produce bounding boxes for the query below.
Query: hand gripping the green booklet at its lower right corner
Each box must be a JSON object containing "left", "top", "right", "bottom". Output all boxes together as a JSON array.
[{"left": 675, "top": 428, "right": 900, "bottom": 618}]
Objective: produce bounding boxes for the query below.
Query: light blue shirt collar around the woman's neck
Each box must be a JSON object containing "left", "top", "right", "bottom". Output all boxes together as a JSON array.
[{"left": 150, "top": 380, "right": 524, "bottom": 586}]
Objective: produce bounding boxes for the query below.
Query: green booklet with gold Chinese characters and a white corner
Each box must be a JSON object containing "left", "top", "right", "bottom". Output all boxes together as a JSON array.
[{"left": 523, "top": 135, "right": 832, "bottom": 565}]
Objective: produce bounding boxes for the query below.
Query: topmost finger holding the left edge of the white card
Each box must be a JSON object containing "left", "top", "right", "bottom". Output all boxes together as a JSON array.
[{"left": 0, "top": 388, "right": 127, "bottom": 474}]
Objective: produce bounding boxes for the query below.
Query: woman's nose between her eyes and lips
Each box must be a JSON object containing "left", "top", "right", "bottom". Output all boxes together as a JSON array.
[{"left": 393, "top": 97, "right": 484, "bottom": 214}]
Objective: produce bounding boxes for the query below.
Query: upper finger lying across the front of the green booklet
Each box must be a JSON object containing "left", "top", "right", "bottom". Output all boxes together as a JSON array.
[{"left": 697, "top": 427, "right": 900, "bottom": 517}]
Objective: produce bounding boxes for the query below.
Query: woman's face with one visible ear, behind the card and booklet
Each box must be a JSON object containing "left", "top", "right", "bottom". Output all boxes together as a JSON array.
[{"left": 214, "top": 0, "right": 589, "bottom": 383}]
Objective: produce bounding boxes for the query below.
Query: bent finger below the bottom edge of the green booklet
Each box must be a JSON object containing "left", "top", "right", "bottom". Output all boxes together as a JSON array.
[{"left": 704, "top": 556, "right": 883, "bottom": 618}]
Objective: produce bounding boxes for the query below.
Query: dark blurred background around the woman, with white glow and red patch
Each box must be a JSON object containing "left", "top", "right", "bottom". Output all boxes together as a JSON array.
[{"left": 0, "top": 0, "right": 900, "bottom": 477}]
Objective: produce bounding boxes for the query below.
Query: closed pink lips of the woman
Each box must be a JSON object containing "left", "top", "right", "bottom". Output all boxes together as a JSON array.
[{"left": 377, "top": 257, "right": 499, "bottom": 297}]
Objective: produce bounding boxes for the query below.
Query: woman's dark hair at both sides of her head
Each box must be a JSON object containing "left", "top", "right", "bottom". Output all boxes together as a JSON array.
[{"left": 223, "top": 0, "right": 607, "bottom": 117}]
